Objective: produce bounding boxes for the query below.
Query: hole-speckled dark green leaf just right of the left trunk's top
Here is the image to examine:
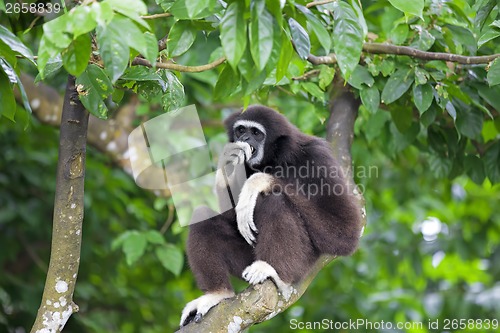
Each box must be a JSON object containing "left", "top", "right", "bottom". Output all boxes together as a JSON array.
[{"left": 76, "top": 64, "right": 113, "bottom": 119}]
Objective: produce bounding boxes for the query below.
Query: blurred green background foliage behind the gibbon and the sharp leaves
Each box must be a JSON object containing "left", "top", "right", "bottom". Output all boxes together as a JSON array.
[{"left": 0, "top": 0, "right": 500, "bottom": 333}]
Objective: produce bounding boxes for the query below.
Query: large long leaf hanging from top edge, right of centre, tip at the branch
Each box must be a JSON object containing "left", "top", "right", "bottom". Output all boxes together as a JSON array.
[{"left": 333, "top": 1, "right": 364, "bottom": 80}]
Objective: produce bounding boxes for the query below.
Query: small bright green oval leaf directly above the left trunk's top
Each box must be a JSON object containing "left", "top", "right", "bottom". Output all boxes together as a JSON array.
[{"left": 62, "top": 34, "right": 92, "bottom": 76}]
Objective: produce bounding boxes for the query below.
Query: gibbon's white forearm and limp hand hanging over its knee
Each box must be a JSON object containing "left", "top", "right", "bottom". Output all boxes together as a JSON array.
[{"left": 236, "top": 172, "right": 274, "bottom": 246}]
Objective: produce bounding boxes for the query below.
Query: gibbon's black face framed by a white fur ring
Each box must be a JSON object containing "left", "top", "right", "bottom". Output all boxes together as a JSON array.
[{"left": 233, "top": 119, "right": 266, "bottom": 166}]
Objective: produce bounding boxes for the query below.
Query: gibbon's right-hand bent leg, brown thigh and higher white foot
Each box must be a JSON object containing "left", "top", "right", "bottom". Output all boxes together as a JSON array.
[{"left": 243, "top": 193, "right": 318, "bottom": 298}]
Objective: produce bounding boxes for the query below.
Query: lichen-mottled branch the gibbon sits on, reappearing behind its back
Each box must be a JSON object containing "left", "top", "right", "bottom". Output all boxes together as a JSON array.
[{"left": 177, "top": 87, "right": 365, "bottom": 333}]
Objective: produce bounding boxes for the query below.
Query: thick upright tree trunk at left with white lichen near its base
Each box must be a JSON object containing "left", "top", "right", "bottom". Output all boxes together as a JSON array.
[{"left": 31, "top": 76, "right": 89, "bottom": 333}]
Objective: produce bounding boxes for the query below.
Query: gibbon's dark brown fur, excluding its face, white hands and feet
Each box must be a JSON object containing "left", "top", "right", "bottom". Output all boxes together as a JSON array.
[{"left": 187, "top": 106, "right": 362, "bottom": 292}]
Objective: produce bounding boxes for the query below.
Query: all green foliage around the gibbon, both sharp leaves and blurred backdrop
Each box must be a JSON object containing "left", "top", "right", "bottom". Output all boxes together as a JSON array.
[{"left": 0, "top": 0, "right": 500, "bottom": 332}]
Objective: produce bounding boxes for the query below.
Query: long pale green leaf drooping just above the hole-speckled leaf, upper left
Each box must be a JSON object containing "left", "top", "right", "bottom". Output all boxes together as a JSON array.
[{"left": 97, "top": 17, "right": 130, "bottom": 82}]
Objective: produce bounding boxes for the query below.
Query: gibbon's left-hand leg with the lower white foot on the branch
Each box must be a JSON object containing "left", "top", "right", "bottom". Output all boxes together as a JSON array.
[{"left": 180, "top": 207, "right": 254, "bottom": 326}]
